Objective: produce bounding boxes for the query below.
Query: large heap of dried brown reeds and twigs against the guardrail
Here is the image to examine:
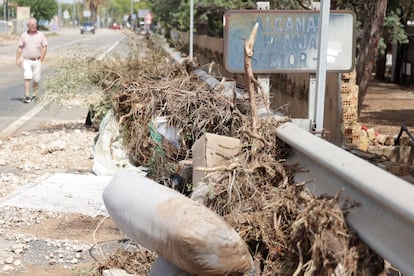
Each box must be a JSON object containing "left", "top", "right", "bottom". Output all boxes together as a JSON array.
[{"left": 85, "top": 33, "right": 390, "bottom": 275}]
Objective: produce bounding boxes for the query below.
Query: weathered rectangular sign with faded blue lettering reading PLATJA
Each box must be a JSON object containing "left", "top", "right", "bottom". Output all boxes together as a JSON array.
[{"left": 224, "top": 10, "right": 355, "bottom": 73}]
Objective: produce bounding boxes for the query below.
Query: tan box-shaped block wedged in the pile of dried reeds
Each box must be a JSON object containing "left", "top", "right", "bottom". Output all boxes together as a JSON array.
[{"left": 192, "top": 133, "right": 242, "bottom": 189}]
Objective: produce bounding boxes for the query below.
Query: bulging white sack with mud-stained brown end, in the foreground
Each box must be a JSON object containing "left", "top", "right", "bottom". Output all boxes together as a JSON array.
[{"left": 103, "top": 172, "right": 253, "bottom": 276}]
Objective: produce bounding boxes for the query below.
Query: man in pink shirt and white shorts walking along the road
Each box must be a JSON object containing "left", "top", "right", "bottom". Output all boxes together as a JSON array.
[{"left": 16, "top": 18, "right": 47, "bottom": 103}]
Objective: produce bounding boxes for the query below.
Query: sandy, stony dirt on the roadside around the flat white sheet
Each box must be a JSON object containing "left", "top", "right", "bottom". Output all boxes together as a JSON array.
[{"left": 0, "top": 118, "right": 123, "bottom": 276}]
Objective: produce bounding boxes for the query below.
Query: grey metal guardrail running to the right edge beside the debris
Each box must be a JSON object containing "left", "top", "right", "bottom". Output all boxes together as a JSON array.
[{"left": 276, "top": 123, "right": 414, "bottom": 275}]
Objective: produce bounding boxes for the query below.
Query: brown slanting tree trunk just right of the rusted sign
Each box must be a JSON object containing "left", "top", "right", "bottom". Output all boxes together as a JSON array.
[{"left": 356, "top": 0, "right": 388, "bottom": 117}]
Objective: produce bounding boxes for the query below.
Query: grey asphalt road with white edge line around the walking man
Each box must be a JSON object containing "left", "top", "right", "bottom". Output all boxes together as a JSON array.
[{"left": 0, "top": 28, "right": 128, "bottom": 136}]
